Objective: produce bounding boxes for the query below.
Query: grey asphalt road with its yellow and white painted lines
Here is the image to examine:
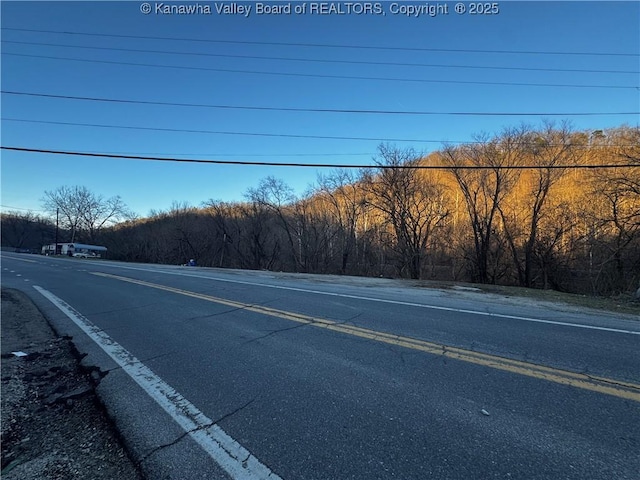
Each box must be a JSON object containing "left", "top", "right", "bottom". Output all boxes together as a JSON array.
[{"left": 2, "top": 253, "right": 640, "bottom": 480}]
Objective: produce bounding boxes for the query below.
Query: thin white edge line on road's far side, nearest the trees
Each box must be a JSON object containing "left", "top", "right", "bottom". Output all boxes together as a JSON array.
[{"left": 95, "top": 265, "right": 640, "bottom": 335}]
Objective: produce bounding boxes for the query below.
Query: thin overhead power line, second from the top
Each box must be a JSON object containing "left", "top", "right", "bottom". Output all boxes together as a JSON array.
[{"left": 3, "top": 40, "right": 640, "bottom": 75}]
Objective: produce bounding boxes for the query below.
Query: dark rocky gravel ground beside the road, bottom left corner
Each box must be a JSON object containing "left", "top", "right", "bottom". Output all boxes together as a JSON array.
[{"left": 0, "top": 288, "right": 142, "bottom": 480}]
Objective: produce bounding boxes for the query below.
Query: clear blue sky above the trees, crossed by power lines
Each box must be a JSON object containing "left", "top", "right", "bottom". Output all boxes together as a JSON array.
[{"left": 1, "top": 1, "right": 640, "bottom": 216}]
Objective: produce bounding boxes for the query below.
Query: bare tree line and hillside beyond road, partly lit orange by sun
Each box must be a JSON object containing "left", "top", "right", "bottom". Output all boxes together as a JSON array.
[{"left": 2, "top": 123, "right": 640, "bottom": 295}]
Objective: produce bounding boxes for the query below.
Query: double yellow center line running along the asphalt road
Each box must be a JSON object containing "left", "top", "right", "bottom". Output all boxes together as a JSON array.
[{"left": 91, "top": 272, "right": 640, "bottom": 402}]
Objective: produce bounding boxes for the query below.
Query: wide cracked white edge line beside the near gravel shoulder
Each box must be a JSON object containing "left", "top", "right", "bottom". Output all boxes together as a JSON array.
[{"left": 33, "top": 285, "right": 282, "bottom": 480}]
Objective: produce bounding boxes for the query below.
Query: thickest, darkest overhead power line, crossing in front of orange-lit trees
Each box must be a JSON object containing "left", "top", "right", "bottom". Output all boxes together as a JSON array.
[{"left": 0, "top": 146, "right": 640, "bottom": 170}]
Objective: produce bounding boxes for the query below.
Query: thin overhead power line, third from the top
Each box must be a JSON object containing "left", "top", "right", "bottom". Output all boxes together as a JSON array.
[{"left": 3, "top": 52, "right": 639, "bottom": 90}]
